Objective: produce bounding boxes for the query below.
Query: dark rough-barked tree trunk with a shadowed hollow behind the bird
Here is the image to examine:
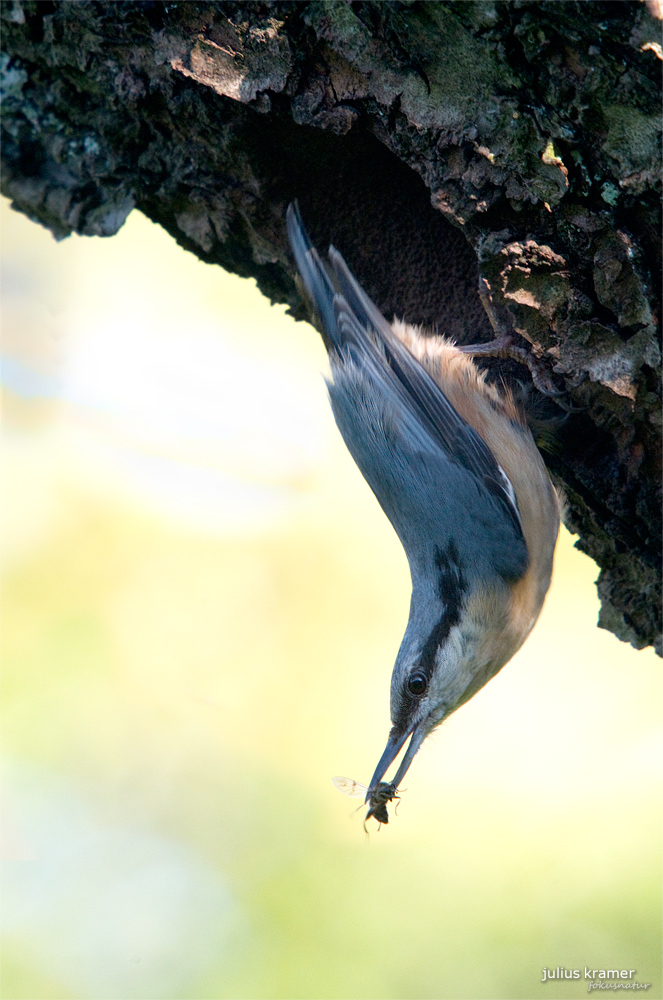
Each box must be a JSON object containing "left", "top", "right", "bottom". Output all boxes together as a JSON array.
[{"left": 0, "top": 0, "right": 661, "bottom": 647}]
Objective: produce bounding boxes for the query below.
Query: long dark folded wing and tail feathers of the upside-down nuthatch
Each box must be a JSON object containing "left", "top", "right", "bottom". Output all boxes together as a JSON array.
[{"left": 287, "top": 205, "right": 523, "bottom": 542}]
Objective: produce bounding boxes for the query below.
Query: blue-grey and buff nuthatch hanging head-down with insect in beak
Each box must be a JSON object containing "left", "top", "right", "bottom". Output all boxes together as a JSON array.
[{"left": 287, "top": 205, "right": 560, "bottom": 822}]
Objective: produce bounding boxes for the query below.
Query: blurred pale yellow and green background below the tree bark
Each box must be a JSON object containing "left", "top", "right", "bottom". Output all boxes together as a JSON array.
[{"left": 2, "top": 197, "right": 662, "bottom": 1000}]
